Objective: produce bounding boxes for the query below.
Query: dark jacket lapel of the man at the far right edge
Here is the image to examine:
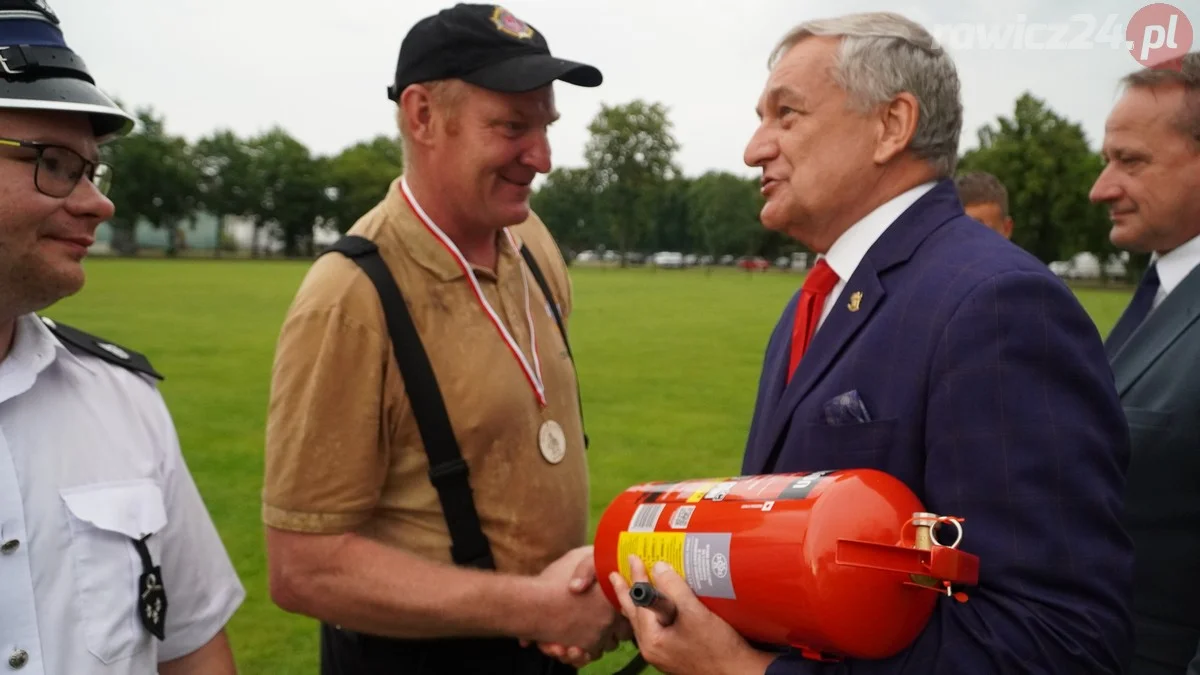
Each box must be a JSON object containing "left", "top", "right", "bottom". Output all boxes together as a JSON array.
[{"left": 1112, "top": 260, "right": 1200, "bottom": 396}]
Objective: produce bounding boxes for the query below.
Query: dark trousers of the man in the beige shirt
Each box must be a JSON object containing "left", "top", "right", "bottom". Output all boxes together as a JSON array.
[{"left": 320, "top": 623, "right": 576, "bottom": 675}]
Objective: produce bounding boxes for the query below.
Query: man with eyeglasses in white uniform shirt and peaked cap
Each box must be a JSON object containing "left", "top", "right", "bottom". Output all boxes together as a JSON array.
[{"left": 0, "top": 0, "right": 245, "bottom": 675}]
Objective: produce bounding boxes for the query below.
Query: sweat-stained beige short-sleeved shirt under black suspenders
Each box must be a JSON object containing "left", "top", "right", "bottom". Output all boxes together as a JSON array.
[{"left": 263, "top": 174, "right": 588, "bottom": 574}]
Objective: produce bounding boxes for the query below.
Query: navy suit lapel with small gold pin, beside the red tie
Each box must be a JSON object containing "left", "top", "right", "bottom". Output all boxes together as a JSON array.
[{"left": 751, "top": 179, "right": 962, "bottom": 472}]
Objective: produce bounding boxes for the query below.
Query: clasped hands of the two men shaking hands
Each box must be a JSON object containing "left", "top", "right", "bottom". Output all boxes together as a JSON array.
[{"left": 521, "top": 546, "right": 634, "bottom": 668}]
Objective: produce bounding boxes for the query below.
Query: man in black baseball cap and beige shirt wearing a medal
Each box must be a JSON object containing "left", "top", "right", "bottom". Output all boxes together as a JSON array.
[{"left": 263, "top": 5, "right": 629, "bottom": 675}]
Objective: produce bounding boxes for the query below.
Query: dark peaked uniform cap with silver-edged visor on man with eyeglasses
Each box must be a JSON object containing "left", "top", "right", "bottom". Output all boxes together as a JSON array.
[{"left": 0, "top": 0, "right": 136, "bottom": 143}]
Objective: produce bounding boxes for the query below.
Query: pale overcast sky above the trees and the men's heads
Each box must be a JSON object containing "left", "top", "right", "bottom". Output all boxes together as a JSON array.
[{"left": 50, "top": 0, "right": 1200, "bottom": 175}]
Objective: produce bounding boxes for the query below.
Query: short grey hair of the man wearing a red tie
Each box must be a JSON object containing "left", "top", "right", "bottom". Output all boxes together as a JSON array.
[{"left": 767, "top": 12, "right": 962, "bottom": 178}]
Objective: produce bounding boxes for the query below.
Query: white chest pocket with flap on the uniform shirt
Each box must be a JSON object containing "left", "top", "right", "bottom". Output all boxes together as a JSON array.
[{"left": 60, "top": 479, "right": 170, "bottom": 663}]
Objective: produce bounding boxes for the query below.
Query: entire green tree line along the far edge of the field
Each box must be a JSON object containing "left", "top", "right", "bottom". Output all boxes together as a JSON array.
[{"left": 102, "top": 94, "right": 1114, "bottom": 273}]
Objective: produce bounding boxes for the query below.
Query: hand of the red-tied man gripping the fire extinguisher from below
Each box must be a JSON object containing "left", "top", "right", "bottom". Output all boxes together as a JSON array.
[{"left": 610, "top": 556, "right": 774, "bottom": 675}]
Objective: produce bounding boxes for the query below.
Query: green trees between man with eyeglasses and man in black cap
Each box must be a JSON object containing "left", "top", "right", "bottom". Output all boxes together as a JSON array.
[{"left": 101, "top": 98, "right": 403, "bottom": 256}]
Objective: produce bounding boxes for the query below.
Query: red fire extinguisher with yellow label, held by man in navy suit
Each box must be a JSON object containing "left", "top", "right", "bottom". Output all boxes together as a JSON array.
[{"left": 595, "top": 470, "right": 979, "bottom": 659}]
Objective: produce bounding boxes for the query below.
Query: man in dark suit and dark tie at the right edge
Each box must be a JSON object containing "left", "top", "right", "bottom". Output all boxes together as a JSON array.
[{"left": 1091, "top": 53, "right": 1200, "bottom": 675}]
